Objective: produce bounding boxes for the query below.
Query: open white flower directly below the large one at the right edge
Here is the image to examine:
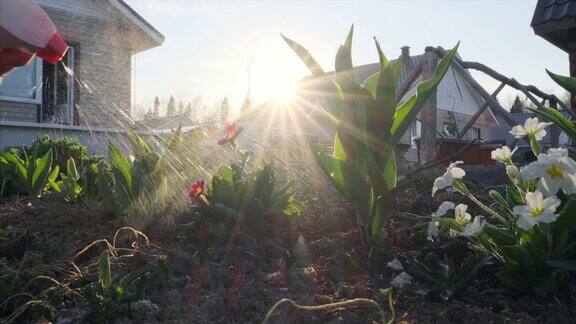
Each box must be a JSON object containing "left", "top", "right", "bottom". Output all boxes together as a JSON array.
[{"left": 513, "top": 191, "right": 560, "bottom": 230}]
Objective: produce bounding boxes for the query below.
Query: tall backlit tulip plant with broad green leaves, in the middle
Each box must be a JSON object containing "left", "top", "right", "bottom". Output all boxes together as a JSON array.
[{"left": 283, "top": 28, "right": 458, "bottom": 242}]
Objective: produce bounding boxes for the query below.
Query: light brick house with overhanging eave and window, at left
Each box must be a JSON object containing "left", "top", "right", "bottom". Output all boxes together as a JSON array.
[{"left": 0, "top": 0, "right": 164, "bottom": 153}]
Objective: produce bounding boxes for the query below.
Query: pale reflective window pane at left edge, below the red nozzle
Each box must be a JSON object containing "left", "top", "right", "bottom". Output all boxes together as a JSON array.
[{"left": 0, "top": 58, "right": 42, "bottom": 104}]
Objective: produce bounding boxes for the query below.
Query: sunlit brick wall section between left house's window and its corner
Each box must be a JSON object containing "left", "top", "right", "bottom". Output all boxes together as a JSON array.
[{"left": 45, "top": 5, "right": 132, "bottom": 127}]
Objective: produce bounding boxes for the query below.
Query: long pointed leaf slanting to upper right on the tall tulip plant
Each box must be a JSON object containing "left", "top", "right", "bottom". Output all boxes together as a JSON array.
[{"left": 390, "top": 43, "right": 460, "bottom": 146}]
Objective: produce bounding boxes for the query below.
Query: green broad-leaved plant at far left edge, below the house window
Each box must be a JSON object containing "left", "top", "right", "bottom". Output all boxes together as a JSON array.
[{"left": 0, "top": 147, "right": 60, "bottom": 196}]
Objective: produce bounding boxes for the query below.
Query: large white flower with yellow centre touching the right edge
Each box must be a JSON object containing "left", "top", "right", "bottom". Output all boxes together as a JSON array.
[{"left": 520, "top": 149, "right": 576, "bottom": 195}]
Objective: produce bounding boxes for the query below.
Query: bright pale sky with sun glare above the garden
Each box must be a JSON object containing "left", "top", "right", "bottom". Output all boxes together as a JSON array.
[{"left": 126, "top": 0, "right": 568, "bottom": 119}]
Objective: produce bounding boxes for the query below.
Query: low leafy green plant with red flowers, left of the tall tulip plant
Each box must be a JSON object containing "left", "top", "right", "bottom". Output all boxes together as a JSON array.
[{"left": 189, "top": 153, "right": 303, "bottom": 219}]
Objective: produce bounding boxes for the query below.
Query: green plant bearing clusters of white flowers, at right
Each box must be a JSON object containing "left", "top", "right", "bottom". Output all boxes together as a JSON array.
[{"left": 428, "top": 69, "right": 576, "bottom": 296}]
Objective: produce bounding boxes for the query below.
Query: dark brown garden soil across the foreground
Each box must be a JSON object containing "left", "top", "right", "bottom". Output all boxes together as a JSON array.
[{"left": 0, "top": 197, "right": 576, "bottom": 323}]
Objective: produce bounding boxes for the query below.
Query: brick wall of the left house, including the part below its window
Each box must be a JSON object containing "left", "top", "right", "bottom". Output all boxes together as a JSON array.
[{"left": 0, "top": 0, "right": 156, "bottom": 128}]
